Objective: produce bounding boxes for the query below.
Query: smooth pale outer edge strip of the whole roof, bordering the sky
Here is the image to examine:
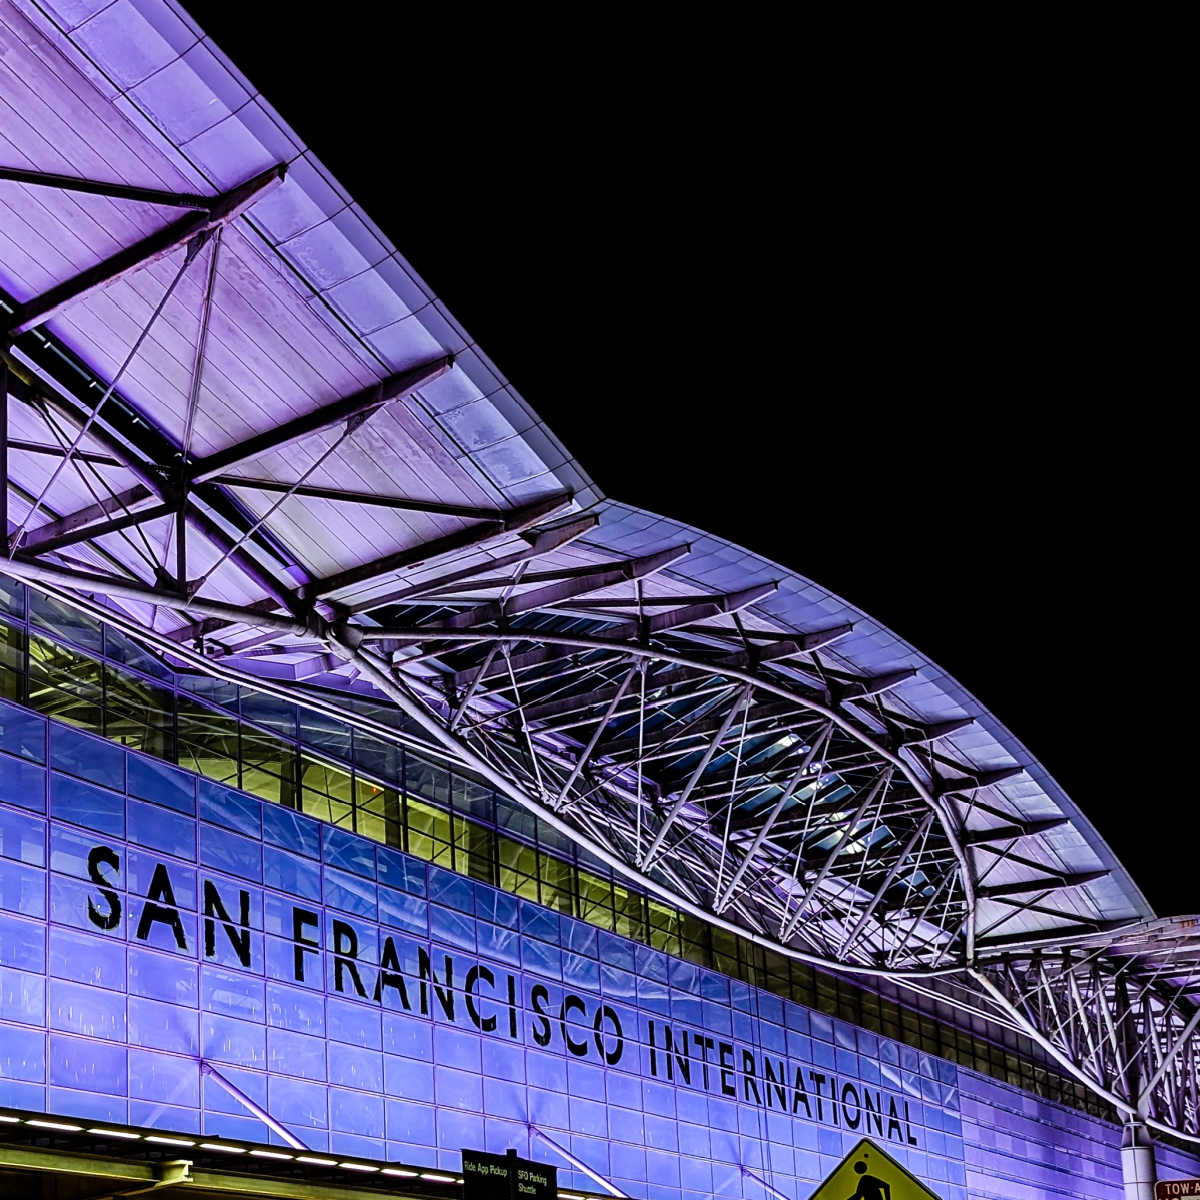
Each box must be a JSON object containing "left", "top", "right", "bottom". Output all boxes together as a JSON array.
[{"left": 0, "top": 0, "right": 1151, "bottom": 916}]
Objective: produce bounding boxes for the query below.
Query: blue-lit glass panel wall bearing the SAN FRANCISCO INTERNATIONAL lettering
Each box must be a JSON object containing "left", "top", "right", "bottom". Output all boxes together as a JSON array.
[{"left": 0, "top": 729, "right": 1195, "bottom": 1200}]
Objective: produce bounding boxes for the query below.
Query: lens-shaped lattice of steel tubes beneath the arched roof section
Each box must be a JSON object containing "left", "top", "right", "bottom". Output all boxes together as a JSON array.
[{"left": 340, "top": 614, "right": 976, "bottom": 972}]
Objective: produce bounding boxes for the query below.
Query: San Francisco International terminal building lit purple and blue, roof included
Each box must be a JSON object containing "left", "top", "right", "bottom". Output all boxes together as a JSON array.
[{"left": 0, "top": 0, "right": 1200, "bottom": 1200}]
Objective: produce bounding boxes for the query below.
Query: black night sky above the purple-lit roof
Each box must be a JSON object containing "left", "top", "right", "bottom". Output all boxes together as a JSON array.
[{"left": 190, "top": 5, "right": 1200, "bottom": 913}]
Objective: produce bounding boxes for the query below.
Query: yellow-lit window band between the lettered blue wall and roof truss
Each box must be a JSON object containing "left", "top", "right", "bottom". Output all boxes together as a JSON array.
[{"left": 0, "top": 578, "right": 1111, "bottom": 1117}]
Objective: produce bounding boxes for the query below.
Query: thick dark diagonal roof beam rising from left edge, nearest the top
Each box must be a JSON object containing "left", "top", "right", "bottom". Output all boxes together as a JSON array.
[{"left": 7, "top": 164, "right": 286, "bottom": 337}]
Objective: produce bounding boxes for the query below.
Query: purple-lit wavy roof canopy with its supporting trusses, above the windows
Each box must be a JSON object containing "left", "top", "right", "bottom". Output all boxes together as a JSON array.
[{"left": 0, "top": 0, "right": 1194, "bottom": 1142}]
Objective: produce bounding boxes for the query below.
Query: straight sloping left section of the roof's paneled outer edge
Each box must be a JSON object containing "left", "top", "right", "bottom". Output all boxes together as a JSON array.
[{"left": 14, "top": 0, "right": 604, "bottom": 508}]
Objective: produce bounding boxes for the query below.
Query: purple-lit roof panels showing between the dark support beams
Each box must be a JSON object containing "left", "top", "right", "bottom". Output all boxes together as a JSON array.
[{"left": 0, "top": 0, "right": 1148, "bottom": 960}]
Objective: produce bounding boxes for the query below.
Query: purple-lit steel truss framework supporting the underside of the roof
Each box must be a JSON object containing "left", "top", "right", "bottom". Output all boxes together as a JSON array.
[{"left": 0, "top": 18, "right": 1200, "bottom": 1141}]
